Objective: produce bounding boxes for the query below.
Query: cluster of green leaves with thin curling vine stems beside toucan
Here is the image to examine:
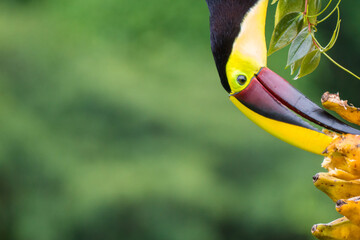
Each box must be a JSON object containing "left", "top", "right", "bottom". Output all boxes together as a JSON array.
[{"left": 268, "top": 0, "right": 350, "bottom": 79}]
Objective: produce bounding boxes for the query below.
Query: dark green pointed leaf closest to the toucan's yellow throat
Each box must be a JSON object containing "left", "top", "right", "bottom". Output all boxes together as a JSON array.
[{"left": 268, "top": 12, "right": 304, "bottom": 55}]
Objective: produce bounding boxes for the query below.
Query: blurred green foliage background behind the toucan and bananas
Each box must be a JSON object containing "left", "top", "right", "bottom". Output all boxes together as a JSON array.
[{"left": 0, "top": 0, "right": 360, "bottom": 240}]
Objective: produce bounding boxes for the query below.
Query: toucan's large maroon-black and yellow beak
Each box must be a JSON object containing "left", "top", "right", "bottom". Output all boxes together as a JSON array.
[{"left": 230, "top": 67, "right": 360, "bottom": 154}]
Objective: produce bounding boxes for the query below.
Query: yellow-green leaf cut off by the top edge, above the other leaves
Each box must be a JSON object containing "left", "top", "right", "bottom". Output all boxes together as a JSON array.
[{"left": 275, "top": 0, "right": 304, "bottom": 26}]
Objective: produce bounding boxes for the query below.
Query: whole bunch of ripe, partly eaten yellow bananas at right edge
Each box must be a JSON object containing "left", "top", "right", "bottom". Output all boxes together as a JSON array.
[{"left": 311, "top": 92, "right": 360, "bottom": 240}]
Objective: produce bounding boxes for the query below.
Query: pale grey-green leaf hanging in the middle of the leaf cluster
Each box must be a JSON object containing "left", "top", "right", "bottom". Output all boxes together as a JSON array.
[{"left": 286, "top": 27, "right": 313, "bottom": 68}]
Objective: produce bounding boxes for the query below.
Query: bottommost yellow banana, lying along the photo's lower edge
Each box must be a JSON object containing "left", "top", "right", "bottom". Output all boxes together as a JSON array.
[{"left": 311, "top": 217, "right": 360, "bottom": 240}]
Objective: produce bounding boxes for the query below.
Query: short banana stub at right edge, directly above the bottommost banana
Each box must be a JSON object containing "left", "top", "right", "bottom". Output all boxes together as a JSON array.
[{"left": 336, "top": 197, "right": 360, "bottom": 226}]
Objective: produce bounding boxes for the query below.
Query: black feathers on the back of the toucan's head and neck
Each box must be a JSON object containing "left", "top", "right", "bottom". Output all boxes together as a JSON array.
[{"left": 206, "top": 0, "right": 259, "bottom": 92}]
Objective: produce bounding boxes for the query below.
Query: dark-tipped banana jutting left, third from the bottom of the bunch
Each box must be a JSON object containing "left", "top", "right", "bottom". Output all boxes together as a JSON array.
[{"left": 313, "top": 173, "right": 360, "bottom": 202}]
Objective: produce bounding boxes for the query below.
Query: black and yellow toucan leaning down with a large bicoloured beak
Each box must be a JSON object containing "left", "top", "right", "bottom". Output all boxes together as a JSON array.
[{"left": 206, "top": 0, "right": 360, "bottom": 155}]
